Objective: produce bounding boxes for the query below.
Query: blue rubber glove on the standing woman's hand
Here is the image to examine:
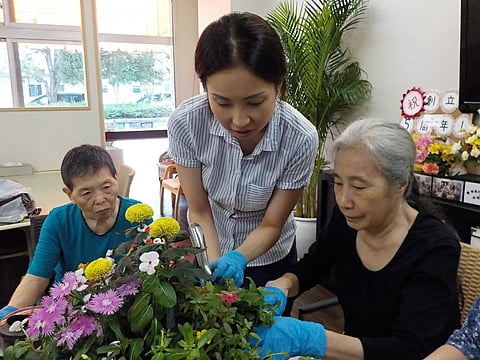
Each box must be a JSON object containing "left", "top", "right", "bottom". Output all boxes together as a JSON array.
[{"left": 209, "top": 250, "right": 247, "bottom": 286}]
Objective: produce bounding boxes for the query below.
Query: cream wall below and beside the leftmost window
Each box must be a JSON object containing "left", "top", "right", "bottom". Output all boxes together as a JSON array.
[{"left": 0, "top": 1, "right": 104, "bottom": 171}]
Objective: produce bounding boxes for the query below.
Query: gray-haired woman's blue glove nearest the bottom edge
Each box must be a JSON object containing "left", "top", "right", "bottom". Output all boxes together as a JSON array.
[{"left": 250, "top": 316, "right": 327, "bottom": 360}]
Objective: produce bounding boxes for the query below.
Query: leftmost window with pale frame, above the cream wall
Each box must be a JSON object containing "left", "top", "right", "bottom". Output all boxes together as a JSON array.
[{"left": 0, "top": 0, "right": 87, "bottom": 108}]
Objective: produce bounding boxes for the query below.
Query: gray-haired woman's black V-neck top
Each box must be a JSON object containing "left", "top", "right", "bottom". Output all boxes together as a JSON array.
[{"left": 291, "top": 207, "right": 460, "bottom": 360}]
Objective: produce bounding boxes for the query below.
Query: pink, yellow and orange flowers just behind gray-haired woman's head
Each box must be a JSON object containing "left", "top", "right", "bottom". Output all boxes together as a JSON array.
[{"left": 412, "top": 133, "right": 456, "bottom": 176}]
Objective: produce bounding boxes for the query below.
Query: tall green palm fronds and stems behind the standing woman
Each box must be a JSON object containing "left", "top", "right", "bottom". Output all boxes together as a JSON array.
[{"left": 267, "top": 0, "right": 372, "bottom": 218}]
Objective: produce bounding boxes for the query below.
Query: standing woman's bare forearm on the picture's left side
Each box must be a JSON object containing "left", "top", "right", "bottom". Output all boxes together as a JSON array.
[{"left": 177, "top": 164, "right": 220, "bottom": 261}]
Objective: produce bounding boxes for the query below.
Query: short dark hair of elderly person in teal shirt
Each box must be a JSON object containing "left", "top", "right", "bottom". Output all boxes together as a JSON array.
[{"left": 60, "top": 144, "right": 117, "bottom": 190}]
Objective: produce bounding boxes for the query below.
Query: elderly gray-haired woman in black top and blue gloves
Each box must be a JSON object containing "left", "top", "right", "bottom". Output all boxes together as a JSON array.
[{"left": 256, "top": 119, "right": 460, "bottom": 360}]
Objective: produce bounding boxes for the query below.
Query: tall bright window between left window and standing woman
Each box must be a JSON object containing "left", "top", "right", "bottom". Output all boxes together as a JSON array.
[{"left": 97, "top": 0, "right": 174, "bottom": 135}]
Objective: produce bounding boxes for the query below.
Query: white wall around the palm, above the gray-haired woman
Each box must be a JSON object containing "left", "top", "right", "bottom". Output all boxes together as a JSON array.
[{"left": 235, "top": 0, "right": 460, "bottom": 125}]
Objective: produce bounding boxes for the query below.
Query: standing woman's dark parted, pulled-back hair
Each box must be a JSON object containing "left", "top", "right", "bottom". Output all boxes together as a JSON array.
[{"left": 195, "top": 12, "right": 287, "bottom": 97}]
